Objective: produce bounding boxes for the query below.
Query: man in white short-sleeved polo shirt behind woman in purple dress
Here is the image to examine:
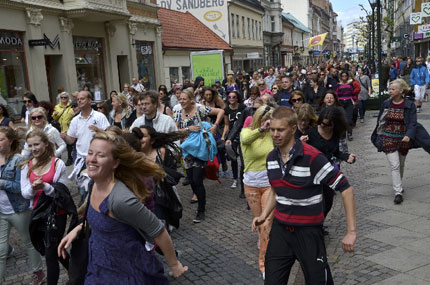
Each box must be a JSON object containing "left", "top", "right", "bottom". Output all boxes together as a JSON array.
[{"left": 61, "top": 91, "right": 109, "bottom": 158}]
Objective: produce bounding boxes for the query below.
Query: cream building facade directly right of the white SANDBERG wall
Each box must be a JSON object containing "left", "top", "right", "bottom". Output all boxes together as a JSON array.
[{"left": 228, "top": 0, "right": 264, "bottom": 72}]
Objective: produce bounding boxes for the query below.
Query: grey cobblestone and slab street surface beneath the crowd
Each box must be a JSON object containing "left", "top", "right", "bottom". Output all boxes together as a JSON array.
[{"left": 4, "top": 103, "right": 430, "bottom": 285}]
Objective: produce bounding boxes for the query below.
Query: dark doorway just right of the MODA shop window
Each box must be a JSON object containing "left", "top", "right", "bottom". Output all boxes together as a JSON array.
[{"left": 45, "top": 55, "right": 63, "bottom": 105}]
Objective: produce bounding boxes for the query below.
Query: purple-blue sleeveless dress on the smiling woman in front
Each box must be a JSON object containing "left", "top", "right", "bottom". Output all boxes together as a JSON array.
[{"left": 85, "top": 192, "right": 168, "bottom": 285}]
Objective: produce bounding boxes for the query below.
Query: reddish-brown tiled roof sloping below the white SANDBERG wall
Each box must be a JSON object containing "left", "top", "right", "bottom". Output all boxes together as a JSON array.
[{"left": 157, "top": 8, "right": 232, "bottom": 50}]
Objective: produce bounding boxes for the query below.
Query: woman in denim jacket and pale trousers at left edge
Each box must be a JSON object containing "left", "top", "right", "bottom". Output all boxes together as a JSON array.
[{"left": 0, "top": 126, "right": 46, "bottom": 284}]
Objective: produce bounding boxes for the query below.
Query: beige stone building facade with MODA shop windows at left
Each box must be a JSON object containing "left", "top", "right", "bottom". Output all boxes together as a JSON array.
[{"left": 0, "top": 0, "right": 164, "bottom": 113}]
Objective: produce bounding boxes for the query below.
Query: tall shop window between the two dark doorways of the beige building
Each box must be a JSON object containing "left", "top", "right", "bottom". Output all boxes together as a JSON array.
[{"left": 73, "top": 37, "right": 106, "bottom": 101}]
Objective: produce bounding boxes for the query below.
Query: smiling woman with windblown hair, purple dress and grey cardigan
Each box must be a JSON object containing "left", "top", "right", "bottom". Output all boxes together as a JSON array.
[{"left": 58, "top": 132, "right": 188, "bottom": 285}]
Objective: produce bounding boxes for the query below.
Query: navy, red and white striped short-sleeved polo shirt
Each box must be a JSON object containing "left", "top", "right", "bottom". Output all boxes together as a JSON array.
[{"left": 266, "top": 140, "right": 349, "bottom": 226}]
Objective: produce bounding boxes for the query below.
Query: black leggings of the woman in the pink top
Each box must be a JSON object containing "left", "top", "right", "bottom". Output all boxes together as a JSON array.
[{"left": 45, "top": 214, "right": 69, "bottom": 285}]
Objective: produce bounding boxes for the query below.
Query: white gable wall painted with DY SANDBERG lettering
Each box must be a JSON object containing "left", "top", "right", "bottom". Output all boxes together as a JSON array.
[{"left": 157, "top": 0, "right": 230, "bottom": 43}]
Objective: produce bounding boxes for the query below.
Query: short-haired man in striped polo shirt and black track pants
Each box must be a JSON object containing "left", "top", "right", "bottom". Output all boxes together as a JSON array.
[{"left": 252, "top": 107, "right": 357, "bottom": 284}]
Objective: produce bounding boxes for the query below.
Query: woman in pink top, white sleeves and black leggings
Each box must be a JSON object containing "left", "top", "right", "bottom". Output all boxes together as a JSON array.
[{"left": 21, "top": 130, "right": 68, "bottom": 285}]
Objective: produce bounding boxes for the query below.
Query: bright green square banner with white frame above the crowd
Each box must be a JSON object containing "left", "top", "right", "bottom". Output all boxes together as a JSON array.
[{"left": 190, "top": 50, "right": 224, "bottom": 86}]
